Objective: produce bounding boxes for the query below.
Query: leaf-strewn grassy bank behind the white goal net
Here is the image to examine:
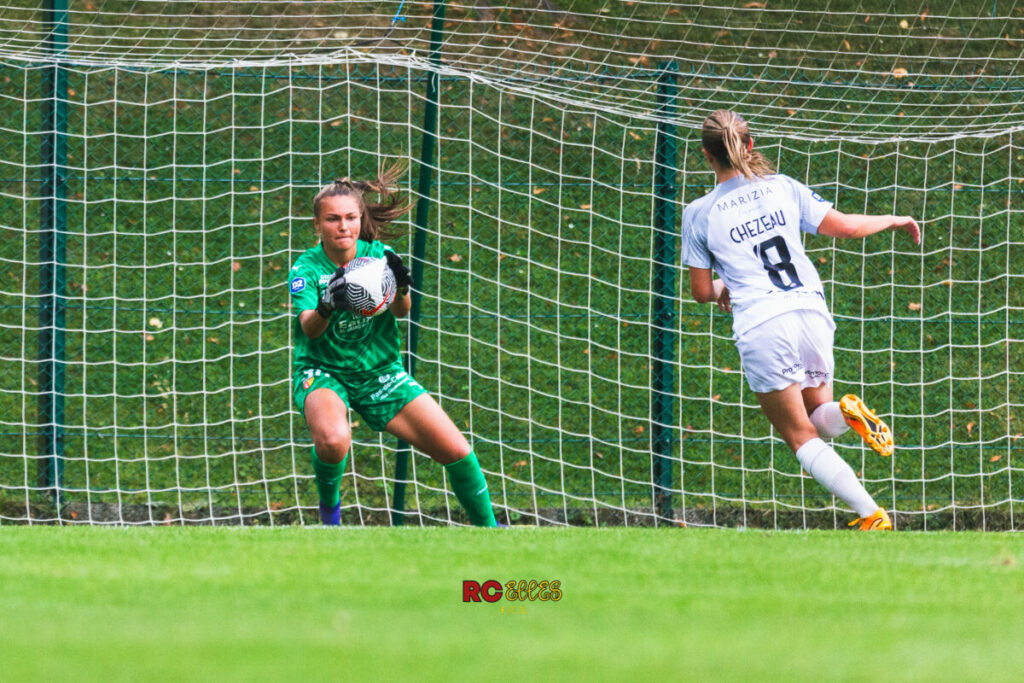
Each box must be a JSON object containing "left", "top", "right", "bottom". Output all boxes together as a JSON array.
[{"left": 0, "top": 0, "right": 1024, "bottom": 528}]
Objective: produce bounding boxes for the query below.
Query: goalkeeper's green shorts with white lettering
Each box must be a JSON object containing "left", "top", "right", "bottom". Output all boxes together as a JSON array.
[{"left": 292, "top": 362, "right": 427, "bottom": 431}]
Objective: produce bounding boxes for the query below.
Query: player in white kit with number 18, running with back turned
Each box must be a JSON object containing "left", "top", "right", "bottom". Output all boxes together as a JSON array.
[{"left": 682, "top": 110, "right": 921, "bottom": 530}]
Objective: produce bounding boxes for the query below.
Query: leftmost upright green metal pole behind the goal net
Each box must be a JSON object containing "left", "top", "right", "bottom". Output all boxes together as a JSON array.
[{"left": 39, "top": 0, "right": 68, "bottom": 515}]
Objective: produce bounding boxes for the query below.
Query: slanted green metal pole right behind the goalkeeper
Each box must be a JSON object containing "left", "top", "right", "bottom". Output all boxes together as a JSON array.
[{"left": 391, "top": 0, "right": 444, "bottom": 526}]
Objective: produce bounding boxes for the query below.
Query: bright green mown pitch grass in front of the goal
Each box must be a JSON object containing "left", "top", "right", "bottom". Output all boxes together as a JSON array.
[{"left": 0, "top": 527, "right": 1024, "bottom": 682}]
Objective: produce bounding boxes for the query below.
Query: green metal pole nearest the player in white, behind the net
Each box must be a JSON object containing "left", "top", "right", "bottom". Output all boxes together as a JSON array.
[{"left": 650, "top": 61, "right": 679, "bottom": 523}]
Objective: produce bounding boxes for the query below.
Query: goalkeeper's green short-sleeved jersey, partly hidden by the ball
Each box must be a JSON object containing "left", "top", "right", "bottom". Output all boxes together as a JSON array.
[{"left": 289, "top": 240, "right": 401, "bottom": 381}]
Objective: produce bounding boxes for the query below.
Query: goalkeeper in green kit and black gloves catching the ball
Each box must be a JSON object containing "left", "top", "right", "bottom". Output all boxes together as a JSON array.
[{"left": 289, "top": 165, "right": 497, "bottom": 526}]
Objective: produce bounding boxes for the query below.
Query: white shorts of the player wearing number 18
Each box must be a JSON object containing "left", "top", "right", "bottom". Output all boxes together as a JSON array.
[{"left": 736, "top": 309, "right": 836, "bottom": 393}]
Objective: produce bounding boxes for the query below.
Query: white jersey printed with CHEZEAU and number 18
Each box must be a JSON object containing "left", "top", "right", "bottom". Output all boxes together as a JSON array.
[{"left": 682, "top": 173, "right": 831, "bottom": 337}]
